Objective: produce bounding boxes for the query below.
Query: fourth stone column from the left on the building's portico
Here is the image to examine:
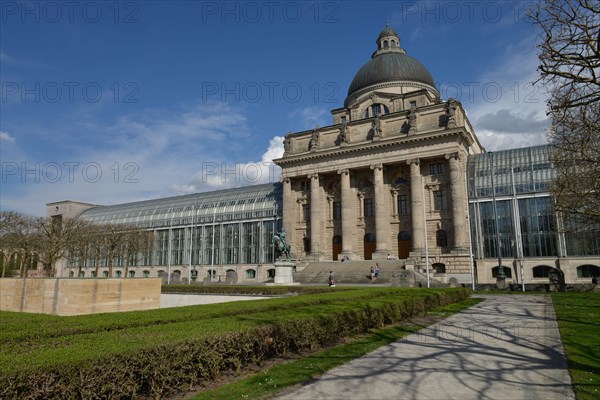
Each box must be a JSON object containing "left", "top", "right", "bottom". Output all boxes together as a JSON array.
[{"left": 371, "top": 164, "right": 390, "bottom": 260}]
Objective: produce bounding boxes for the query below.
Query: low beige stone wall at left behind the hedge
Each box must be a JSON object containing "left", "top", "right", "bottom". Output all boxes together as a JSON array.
[{"left": 0, "top": 278, "right": 161, "bottom": 315}]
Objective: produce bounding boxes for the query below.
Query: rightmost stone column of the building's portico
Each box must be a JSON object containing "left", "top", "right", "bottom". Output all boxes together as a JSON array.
[{"left": 446, "top": 153, "right": 469, "bottom": 250}]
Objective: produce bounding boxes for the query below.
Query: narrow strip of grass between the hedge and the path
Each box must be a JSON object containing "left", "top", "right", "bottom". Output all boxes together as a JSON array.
[{"left": 192, "top": 298, "right": 483, "bottom": 400}]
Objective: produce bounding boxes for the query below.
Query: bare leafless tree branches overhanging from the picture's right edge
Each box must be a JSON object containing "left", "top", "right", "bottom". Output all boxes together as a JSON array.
[{"left": 528, "top": 0, "right": 600, "bottom": 225}]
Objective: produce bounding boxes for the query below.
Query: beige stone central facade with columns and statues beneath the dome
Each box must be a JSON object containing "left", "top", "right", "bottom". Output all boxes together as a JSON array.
[{"left": 275, "top": 28, "right": 483, "bottom": 282}]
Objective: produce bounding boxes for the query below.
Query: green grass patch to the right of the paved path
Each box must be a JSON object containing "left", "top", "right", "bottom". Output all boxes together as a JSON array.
[{"left": 552, "top": 292, "right": 600, "bottom": 400}]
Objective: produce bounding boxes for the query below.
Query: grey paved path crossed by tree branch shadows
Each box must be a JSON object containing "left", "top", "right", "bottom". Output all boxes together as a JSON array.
[{"left": 279, "top": 295, "right": 575, "bottom": 400}]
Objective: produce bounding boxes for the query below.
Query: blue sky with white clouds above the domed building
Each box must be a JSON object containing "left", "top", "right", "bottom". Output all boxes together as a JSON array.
[{"left": 0, "top": 1, "right": 548, "bottom": 215}]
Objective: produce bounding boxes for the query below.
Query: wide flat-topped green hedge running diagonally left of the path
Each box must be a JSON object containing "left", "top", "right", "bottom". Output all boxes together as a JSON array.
[{"left": 0, "top": 287, "right": 470, "bottom": 399}]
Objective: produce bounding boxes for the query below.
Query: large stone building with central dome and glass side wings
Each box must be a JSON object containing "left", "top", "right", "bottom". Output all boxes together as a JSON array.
[{"left": 48, "top": 26, "right": 600, "bottom": 283}]
